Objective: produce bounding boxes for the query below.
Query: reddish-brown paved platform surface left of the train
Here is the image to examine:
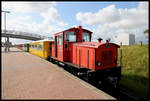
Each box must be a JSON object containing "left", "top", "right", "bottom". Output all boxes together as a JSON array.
[{"left": 1, "top": 48, "right": 115, "bottom": 100}]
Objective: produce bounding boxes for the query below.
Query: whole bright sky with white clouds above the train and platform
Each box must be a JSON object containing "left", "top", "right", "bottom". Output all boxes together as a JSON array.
[{"left": 1, "top": 1, "right": 149, "bottom": 44}]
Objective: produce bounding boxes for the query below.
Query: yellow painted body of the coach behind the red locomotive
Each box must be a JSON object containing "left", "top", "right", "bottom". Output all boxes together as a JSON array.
[{"left": 29, "top": 41, "right": 50, "bottom": 59}]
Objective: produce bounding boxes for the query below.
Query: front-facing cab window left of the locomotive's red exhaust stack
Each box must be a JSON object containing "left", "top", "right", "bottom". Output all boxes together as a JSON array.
[{"left": 65, "top": 31, "right": 76, "bottom": 42}]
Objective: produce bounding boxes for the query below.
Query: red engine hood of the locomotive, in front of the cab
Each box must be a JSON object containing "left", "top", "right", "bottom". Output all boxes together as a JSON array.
[{"left": 72, "top": 42, "right": 119, "bottom": 70}]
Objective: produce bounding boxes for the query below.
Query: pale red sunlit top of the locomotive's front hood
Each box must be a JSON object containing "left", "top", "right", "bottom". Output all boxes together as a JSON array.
[{"left": 73, "top": 42, "right": 120, "bottom": 48}]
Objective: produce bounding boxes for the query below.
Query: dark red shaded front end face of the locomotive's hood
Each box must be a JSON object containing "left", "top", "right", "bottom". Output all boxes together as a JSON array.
[{"left": 96, "top": 43, "right": 119, "bottom": 70}]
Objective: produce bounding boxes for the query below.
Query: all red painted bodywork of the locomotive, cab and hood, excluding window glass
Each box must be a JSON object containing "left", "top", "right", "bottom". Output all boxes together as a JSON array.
[{"left": 51, "top": 26, "right": 119, "bottom": 71}]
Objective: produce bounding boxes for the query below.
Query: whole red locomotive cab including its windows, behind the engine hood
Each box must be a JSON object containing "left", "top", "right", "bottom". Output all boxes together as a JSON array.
[{"left": 55, "top": 26, "right": 92, "bottom": 62}]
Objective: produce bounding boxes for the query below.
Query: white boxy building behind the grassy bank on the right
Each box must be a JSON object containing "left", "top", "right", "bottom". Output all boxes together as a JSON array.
[{"left": 114, "top": 34, "right": 135, "bottom": 45}]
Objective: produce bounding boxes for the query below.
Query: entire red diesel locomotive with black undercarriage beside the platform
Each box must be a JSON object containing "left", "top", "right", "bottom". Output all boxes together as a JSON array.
[{"left": 49, "top": 26, "right": 121, "bottom": 87}]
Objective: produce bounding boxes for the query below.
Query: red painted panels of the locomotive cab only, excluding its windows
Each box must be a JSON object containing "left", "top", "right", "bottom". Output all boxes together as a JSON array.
[{"left": 55, "top": 26, "right": 92, "bottom": 62}]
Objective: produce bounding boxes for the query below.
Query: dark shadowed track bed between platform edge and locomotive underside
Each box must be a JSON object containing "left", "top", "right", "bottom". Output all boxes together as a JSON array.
[{"left": 53, "top": 61, "right": 144, "bottom": 100}]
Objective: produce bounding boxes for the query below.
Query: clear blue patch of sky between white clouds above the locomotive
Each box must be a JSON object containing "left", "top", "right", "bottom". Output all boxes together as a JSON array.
[{"left": 56, "top": 2, "right": 138, "bottom": 27}]
